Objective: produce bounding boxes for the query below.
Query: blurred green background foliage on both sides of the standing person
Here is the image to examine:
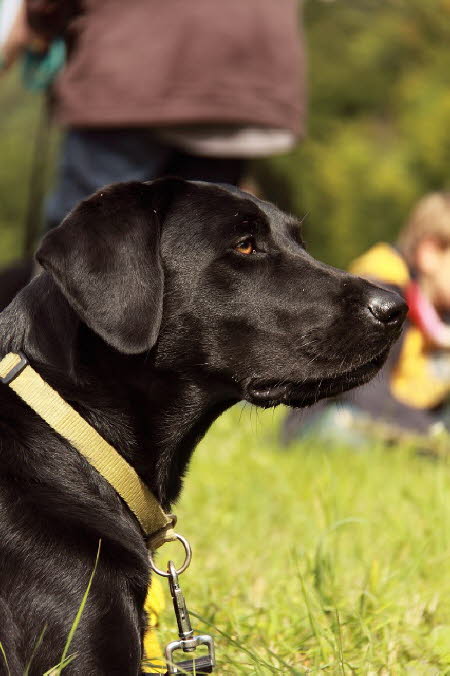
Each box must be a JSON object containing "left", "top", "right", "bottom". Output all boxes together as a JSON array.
[{"left": 0, "top": 0, "right": 450, "bottom": 266}]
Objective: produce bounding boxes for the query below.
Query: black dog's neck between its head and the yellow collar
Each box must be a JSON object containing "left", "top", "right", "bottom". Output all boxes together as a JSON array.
[{"left": 0, "top": 273, "right": 237, "bottom": 508}]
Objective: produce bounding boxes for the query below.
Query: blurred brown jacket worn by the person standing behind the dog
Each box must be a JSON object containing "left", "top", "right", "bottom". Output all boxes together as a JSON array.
[{"left": 27, "top": 0, "right": 304, "bottom": 134}]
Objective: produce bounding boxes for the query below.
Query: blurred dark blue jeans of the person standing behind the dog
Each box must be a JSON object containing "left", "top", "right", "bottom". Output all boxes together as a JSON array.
[{"left": 45, "top": 127, "right": 245, "bottom": 229}]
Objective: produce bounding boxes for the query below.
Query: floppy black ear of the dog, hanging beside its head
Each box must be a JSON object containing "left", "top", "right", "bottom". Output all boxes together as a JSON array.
[{"left": 36, "top": 179, "right": 186, "bottom": 354}]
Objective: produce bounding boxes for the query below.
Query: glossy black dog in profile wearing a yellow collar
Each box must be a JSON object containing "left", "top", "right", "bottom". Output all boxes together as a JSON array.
[{"left": 0, "top": 179, "right": 406, "bottom": 676}]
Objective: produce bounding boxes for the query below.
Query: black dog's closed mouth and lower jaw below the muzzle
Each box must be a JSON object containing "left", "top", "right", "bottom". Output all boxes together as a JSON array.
[{"left": 245, "top": 347, "right": 389, "bottom": 408}]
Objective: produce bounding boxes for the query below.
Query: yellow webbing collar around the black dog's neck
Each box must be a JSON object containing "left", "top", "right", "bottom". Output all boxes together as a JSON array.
[{"left": 0, "top": 352, "right": 174, "bottom": 549}]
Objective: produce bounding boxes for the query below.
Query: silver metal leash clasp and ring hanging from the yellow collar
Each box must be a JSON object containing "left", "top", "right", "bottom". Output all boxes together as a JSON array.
[{"left": 150, "top": 535, "right": 216, "bottom": 676}]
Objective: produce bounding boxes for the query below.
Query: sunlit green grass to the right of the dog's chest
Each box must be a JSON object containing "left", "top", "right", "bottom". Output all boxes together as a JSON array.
[{"left": 153, "top": 408, "right": 450, "bottom": 675}]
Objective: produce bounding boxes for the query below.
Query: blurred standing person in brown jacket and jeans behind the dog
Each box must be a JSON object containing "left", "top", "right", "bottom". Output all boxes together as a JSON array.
[{"left": 1, "top": 0, "right": 305, "bottom": 227}]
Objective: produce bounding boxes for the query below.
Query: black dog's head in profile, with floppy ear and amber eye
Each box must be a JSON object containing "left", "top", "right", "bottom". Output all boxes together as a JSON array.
[{"left": 37, "top": 179, "right": 406, "bottom": 406}]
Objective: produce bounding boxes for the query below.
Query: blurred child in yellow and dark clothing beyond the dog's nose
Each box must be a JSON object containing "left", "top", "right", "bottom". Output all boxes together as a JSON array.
[{"left": 284, "top": 193, "right": 450, "bottom": 443}]
